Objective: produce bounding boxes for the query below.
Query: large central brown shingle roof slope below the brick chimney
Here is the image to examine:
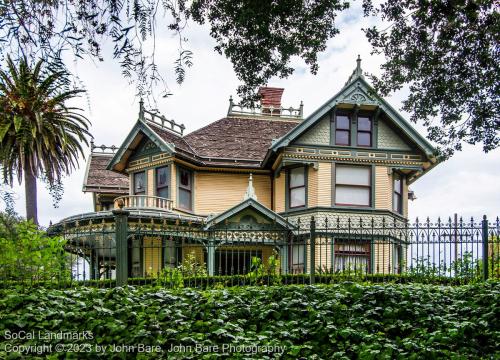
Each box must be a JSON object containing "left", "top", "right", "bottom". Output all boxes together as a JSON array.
[{"left": 184, "top": 118, "right": 298, "bottom": 161}]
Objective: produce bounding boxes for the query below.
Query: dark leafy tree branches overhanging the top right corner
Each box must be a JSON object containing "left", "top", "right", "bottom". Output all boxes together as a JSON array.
[{"left": 364, "top": 0, "right": 500, "bottom": 157}]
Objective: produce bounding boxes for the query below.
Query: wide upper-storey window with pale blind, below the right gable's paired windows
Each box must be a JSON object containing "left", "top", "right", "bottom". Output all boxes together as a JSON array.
[{"left": 335, "top": 165, "right": 371, "bottom": 206}]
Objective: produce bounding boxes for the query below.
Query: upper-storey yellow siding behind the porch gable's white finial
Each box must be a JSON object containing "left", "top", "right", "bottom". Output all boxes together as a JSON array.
[{"left": 194, "top": 172, "right": 271, "bottom": 215}]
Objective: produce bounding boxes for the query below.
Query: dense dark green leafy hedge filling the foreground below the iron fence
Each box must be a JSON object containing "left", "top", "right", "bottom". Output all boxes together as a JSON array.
[{"left": 0, "top": 282, "right": 500, "bottom": 359}]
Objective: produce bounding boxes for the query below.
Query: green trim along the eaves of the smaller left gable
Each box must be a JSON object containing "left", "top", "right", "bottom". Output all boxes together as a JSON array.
[{"left": 107, "top": 120, "right": 175, "bottom": 172}]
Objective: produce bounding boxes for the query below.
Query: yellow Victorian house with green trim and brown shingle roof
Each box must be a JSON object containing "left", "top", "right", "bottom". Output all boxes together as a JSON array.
[{"left": 61, "top": 58, "right": 437, "bottom": 276}]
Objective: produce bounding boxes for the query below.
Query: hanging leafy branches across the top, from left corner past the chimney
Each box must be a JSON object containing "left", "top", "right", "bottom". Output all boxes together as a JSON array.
[{"left": 0, "top": 0, "right": 349, "bottom": 101}]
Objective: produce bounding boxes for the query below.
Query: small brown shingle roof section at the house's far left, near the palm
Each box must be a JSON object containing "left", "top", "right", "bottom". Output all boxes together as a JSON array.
[{"left": 83, "top": 153, "right": 129, "bottom": 194}]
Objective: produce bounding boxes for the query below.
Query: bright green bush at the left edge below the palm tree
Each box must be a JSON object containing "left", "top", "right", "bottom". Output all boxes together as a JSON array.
[{"left": 0, "top": 214, "right": 70, "bottom": 284}]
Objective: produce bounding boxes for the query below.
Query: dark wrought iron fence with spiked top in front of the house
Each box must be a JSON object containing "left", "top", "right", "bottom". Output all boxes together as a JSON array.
[{"left": 0, "top": 210, "right": 500, "bottom": 288}]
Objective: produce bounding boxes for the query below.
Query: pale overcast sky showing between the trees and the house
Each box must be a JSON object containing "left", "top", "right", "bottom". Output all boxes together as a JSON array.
[{"left": 0, "top": 3, "right": 500, "bottom": 225}]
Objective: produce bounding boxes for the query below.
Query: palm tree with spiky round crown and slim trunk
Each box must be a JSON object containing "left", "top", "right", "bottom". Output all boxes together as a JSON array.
[{"left": 0, "top": 57, "right": 90, "bottom": 223}]
